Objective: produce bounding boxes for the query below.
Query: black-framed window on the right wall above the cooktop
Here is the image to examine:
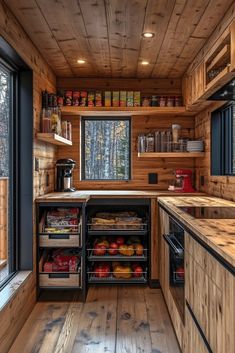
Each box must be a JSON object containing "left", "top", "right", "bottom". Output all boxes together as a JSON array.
[{"left": 211, "top": 103, "right": 235, "bottom": 175}]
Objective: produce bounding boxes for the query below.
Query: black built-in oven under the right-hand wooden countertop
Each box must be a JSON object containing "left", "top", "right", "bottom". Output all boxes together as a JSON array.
[{"left": 164, "top": 217, "right": 185, "bottom": 322}]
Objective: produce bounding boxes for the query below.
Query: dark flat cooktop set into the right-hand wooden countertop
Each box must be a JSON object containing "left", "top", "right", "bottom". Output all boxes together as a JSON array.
[{"left": 179, "top": 206, "right": 235, "bottom": 219}]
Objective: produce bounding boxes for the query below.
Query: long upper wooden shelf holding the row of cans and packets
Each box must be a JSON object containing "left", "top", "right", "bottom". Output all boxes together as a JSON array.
[{"left": 61, "top": 107, "right": 189, "bottom": 116}]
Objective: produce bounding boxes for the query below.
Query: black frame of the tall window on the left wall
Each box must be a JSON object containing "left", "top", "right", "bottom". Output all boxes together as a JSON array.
[{"left": 0, "top": 36, "right": 34, "bottom": 290}]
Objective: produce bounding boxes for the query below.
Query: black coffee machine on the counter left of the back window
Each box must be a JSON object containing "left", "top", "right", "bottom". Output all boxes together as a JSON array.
[{"left": 56, "top": 159, "right": 76, "bottom": 192}]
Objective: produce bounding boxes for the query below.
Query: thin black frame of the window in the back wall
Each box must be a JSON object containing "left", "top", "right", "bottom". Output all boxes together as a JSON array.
[{"left": 80, "top": 115, "right": 132, "bottom": 183}]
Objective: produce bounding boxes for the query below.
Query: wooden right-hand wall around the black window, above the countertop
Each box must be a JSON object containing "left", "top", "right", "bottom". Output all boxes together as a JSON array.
[{"left": 195, "top": 103, "right": 235, "bottom": 201}]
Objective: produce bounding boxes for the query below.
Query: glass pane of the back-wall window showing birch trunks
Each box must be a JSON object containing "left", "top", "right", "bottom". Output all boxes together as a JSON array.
[{"left": 81, "top": 118, "right": 131, "bottom": 180}]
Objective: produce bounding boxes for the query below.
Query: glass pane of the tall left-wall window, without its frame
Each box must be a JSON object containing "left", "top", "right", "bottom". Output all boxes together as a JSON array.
[{"left": 0, "top": 59, "right": 15, "bottom": 285}]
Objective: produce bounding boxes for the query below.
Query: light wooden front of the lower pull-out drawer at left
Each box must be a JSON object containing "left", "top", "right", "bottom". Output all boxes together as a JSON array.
[{"left": 39, "top": 271, "right": 81, "bottom": 288}]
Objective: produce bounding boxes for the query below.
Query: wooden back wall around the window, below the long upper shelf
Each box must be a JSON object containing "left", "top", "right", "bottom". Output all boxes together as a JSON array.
[{"left": 57, "top": 116, "right": 194, "bottom": 190}]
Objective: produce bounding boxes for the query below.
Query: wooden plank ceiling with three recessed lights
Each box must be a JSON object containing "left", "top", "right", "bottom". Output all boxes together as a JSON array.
[{"left": 5, "top": 0, "right": 233, "bottom": 78}]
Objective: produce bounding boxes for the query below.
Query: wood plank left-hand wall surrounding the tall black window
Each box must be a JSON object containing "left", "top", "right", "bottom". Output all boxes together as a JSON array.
[{"left": 0, "top": 0, "right": 56, "bottom": 353}]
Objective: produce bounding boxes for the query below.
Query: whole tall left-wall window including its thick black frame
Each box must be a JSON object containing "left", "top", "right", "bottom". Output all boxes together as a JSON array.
[{"left": 0, "top": 36, "right": 33, "bottom": 288}]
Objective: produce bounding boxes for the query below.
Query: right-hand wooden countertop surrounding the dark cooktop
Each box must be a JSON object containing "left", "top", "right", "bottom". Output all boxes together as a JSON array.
[{"left": 158, "top": 196, "right": 235, "bottom": 271}]
